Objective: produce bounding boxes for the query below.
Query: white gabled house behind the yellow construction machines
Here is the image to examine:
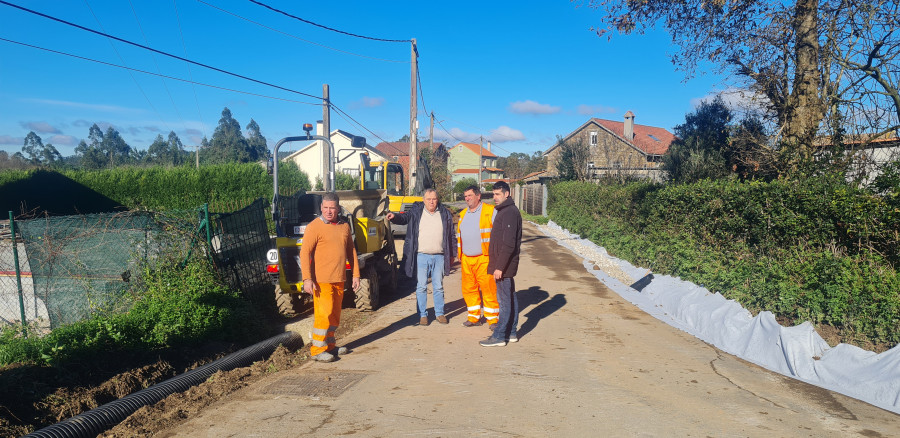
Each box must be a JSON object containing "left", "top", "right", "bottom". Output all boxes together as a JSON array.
[{"left": 282, "top": 122, "right": 386, "bottom": 186}]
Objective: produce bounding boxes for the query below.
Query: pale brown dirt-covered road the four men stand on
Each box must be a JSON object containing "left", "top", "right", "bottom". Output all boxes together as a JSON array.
[{"left": 151, "top": 225, "right": 900, "bottom": 437}]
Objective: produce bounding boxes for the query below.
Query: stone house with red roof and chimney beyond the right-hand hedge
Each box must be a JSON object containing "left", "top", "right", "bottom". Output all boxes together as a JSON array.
[{"left": 544, "top": 111, "right": 675, "bottom": 181}]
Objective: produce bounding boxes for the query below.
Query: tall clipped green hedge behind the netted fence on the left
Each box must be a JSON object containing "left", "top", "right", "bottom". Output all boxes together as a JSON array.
[{"left": 0, "top": 163, "right": 310, "bottom": 214}]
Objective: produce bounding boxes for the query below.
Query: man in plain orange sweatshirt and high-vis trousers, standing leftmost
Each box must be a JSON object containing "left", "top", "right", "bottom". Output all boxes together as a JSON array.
[{"left": 300, "top": 192, "right": 359, "bottom": 362}]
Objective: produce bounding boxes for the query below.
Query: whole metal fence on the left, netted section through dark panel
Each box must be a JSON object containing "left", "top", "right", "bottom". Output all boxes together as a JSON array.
[{"left": 0, "top": 198, "right": 280, "bottom": 332}]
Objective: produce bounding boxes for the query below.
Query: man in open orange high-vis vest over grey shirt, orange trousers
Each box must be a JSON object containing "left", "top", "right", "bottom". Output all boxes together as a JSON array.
[{"left": 456, "top": 186, "right": 500, "bottom": 327}]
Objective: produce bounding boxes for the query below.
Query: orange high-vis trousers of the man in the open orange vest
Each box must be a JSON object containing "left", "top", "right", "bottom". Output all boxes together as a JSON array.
[{"left": 459, "top": 254, "right": 500, "bottom": 324}]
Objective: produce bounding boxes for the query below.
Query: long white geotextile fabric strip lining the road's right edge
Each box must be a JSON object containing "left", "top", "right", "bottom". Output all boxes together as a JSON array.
[{"left": 539, "top": 221, "right": 900, "bottom": 413}]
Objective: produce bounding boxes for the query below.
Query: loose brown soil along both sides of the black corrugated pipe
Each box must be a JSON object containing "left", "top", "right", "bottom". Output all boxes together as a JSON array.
[{"left": 0, "top": 309, "right": 369, "bottom": 437}]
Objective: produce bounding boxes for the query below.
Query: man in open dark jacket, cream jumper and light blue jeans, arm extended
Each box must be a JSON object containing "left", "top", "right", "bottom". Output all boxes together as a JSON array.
[{"left": 387, "top": 189, "right": 456, "bottom": 326}]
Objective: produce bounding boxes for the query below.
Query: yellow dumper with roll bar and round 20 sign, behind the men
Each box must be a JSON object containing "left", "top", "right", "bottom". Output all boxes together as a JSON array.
[{"left": 266, "top": 124, "right": 398, "bottom": 316}]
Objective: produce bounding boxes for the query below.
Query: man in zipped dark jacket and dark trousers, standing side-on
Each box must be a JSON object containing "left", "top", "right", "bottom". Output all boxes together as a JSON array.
[{"left": 479, "top": 181, "right": 522, "bottom": 347}]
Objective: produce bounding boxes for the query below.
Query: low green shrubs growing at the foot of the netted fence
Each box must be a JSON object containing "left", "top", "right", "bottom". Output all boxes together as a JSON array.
[{"left": 0, "top": 259, "right": 264, "bottom": 365}]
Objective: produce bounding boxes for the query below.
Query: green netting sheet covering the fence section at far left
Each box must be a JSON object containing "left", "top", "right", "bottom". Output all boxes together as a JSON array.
[{"left": 16, "top": 212, "right": 197, "bottom": 329}]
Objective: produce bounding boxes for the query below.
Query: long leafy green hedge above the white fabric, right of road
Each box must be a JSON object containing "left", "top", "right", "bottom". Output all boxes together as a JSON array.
[{"left": 549, "top": 179, "right": 900, "bottom": 345}]
